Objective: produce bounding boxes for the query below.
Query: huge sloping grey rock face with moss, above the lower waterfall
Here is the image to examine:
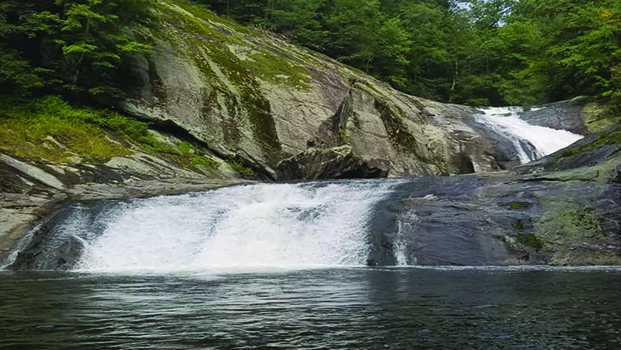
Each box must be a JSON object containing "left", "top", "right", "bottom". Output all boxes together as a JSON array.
[{"left": 119, "top": 2, "right": 516, "bottom": 179}]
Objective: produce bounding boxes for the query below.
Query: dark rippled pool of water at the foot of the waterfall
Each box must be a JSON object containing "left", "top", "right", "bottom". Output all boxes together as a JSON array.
[{"left": 0, "top": 267, "right": 621, "bottom": 349}]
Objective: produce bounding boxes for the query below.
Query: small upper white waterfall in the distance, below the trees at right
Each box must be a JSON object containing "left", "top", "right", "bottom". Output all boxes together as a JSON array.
[{"left": 477, "top": 107, "right": 583, "bottom": 164}]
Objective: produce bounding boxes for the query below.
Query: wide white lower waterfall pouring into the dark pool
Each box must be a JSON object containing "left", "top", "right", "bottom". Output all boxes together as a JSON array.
[{"left": 78, "top": 181, "right": 398, "bottom": 271}]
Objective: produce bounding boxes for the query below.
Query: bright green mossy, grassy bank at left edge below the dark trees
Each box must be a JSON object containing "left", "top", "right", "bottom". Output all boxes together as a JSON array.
[{"left": 0, "top": 96, "right": 140, "bottom": 162}]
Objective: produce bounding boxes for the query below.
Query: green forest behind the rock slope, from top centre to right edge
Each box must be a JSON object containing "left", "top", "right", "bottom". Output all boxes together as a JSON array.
[{"left": 200, "top": 0, "right": 621, "bottom": 105}]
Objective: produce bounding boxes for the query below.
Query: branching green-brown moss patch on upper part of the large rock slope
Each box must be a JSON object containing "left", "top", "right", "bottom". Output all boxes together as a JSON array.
[{"left": 161, "top": 5, "right": 286, "bottom": 158}]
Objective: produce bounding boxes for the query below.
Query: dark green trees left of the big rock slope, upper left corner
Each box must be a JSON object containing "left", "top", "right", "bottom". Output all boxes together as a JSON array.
[{"left": 0, "top": 0, "right": 154, "bottom": 99}]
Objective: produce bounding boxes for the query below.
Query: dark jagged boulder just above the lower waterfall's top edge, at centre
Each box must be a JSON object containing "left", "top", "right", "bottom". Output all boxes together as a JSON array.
[{"left": 277, "top": 146, "right": 389, "bottom": 180}]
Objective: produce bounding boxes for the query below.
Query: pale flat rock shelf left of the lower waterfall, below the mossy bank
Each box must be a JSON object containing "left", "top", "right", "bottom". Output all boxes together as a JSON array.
[{"left": 0, "top": 155, "right": 249, "bottom": 265}]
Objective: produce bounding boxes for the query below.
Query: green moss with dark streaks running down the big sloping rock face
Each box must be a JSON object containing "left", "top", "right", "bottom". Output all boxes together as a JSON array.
[{"left": 156, "top": 4, "right": 284, "bottom": 159}]
